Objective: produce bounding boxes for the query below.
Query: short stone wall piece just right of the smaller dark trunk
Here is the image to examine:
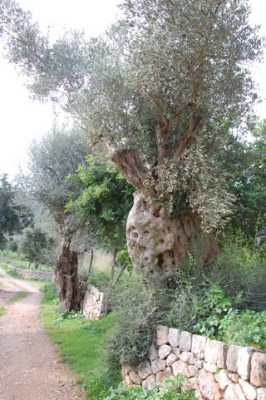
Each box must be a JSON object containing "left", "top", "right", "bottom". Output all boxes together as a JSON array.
[{"left": 82, "top": 284, "right": 107, "bottom": 319}]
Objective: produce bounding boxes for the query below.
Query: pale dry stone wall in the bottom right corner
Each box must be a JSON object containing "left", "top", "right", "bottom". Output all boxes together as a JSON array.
[{"left": 122, "top": 326, "right": 266, "bottom": 400}]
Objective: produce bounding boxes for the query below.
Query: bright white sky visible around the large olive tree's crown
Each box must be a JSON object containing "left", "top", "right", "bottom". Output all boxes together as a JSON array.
[{"left": 0, "top": 0, "right": 266, "bottom": 177}]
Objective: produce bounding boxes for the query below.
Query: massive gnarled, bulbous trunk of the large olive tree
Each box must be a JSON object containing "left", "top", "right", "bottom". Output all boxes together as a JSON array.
[{"left": 127, "top": 192, "right": 218, "bottom": 283}]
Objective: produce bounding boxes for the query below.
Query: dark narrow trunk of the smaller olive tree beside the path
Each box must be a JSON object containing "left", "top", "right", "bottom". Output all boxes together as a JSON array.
[{"left": 54, "top": 242, "right": 85, "bottom": 311}]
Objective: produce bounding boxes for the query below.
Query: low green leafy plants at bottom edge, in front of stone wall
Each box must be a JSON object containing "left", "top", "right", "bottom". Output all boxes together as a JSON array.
[{"left": 104, "top": 376, "right": 196, "bottom": 400}]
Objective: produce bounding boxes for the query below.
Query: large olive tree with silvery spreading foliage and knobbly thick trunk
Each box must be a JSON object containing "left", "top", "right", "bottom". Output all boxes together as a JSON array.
[{"left": 1, "top": 0, "right": 262, "bottom": 282}]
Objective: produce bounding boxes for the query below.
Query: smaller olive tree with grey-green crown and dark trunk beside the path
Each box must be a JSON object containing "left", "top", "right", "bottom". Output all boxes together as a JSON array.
[{"left": 26, "top": 127, "right": 89, "bottom": 310}]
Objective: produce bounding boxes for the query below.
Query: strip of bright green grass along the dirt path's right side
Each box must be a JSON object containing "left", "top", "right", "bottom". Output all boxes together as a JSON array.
[{"left": 41, "top": 285, "right": 121, "bottom": 400}]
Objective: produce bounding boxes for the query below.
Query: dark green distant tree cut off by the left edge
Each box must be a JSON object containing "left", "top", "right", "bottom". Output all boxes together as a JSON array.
[{"left": 0, "top": 174, "right": 32, "bottom": 247}]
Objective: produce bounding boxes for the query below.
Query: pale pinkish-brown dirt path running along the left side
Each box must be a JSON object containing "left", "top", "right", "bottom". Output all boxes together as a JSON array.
[{"left": 0, "top": 269, "right": 86, "bottom": 400}]
